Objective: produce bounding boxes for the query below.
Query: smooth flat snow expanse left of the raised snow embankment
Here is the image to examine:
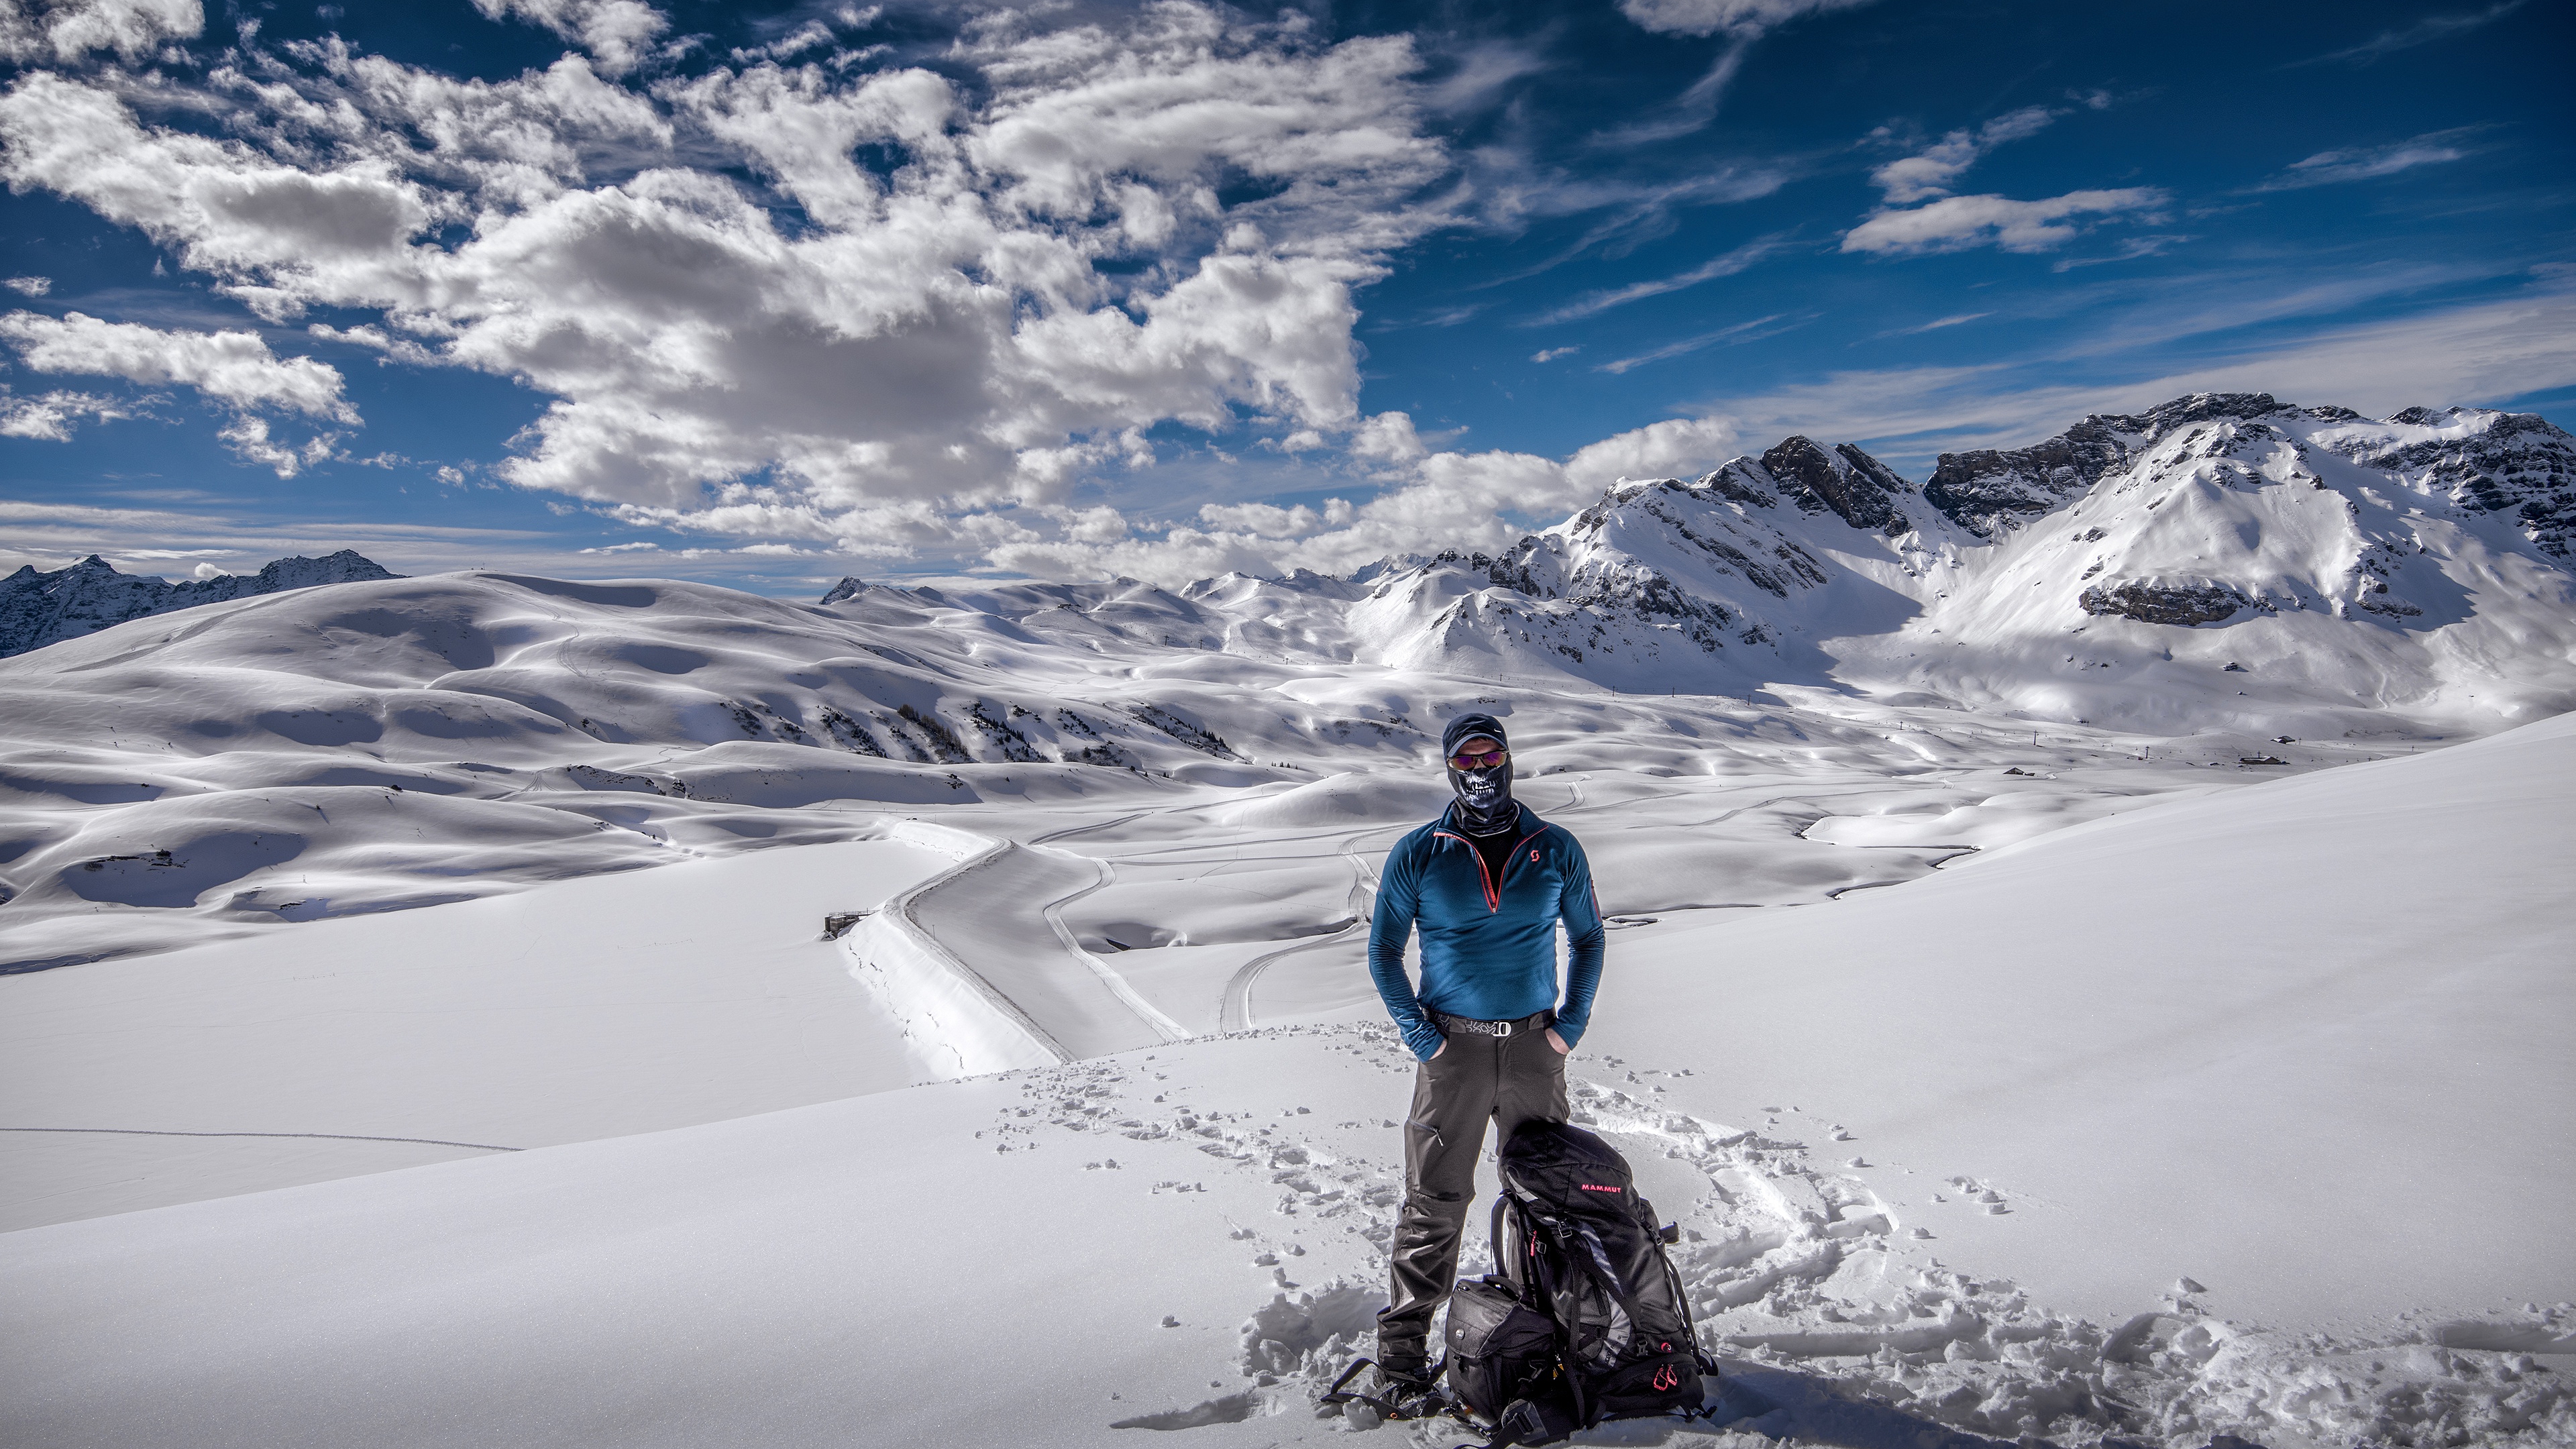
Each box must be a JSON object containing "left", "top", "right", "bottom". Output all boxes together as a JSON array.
[{"left": 0, "top": 841, "right": 951, "bottom": 1230}]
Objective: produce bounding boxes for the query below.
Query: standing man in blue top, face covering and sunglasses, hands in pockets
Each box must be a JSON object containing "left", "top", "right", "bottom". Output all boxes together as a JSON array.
[{"left": 1368, "top": 714, "right": 1602, "bottom": 1403}]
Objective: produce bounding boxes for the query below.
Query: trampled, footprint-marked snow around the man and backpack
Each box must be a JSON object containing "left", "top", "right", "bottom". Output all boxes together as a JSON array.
[{"left": 979, "top": 1024, "right": 2576, "bottom": 1449}]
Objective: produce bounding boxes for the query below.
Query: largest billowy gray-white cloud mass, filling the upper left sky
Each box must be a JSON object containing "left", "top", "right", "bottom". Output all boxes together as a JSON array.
[{"left": 0, "top": 0, "right": 1453, "bottom": 523}]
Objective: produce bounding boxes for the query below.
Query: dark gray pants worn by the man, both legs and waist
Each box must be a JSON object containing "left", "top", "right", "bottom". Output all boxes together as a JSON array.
[{"left": 1378, "top": 1013, "right": 1566, "bottom": 1372}]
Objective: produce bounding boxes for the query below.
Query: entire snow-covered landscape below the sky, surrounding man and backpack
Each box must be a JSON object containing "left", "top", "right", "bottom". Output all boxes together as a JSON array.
[{"left": 0, "top": 394, "right": 2576, "bottom": 1449}]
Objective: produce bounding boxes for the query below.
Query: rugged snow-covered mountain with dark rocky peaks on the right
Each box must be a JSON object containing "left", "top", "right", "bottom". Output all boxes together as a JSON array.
[{"left": 1352, "top": 394, "right": 2576, "bottom": 730}]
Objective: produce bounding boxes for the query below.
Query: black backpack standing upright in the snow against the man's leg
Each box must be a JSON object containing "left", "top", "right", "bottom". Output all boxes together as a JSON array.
[{"left": 1445, "top": 1122, "right": 1718, "bottom": 1446}]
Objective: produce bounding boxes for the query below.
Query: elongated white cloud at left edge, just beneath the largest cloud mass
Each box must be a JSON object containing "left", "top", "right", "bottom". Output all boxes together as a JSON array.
[{"left": 0, "top": 312, "right": 358, "bottom": 423}]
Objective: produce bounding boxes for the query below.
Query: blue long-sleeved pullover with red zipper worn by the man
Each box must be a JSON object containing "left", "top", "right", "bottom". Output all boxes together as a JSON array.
[{"left": 1368, "top": 807, "right": 1602, "bottom": 1062}]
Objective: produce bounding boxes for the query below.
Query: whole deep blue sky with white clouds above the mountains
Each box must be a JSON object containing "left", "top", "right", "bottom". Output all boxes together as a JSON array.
[{"left": 0, "top": 0, "right": 2576, "bottom": 596}]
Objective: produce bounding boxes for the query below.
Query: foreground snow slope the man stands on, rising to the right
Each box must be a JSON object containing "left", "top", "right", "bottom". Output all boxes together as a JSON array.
[{"left": 0, "top": 719, "right": 2576, "bottom": 1449}]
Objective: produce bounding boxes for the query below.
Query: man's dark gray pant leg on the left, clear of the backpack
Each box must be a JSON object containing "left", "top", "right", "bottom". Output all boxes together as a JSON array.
[{"left": 1378, "top": 1034, "right": 1507, "bottom": 1369}]
